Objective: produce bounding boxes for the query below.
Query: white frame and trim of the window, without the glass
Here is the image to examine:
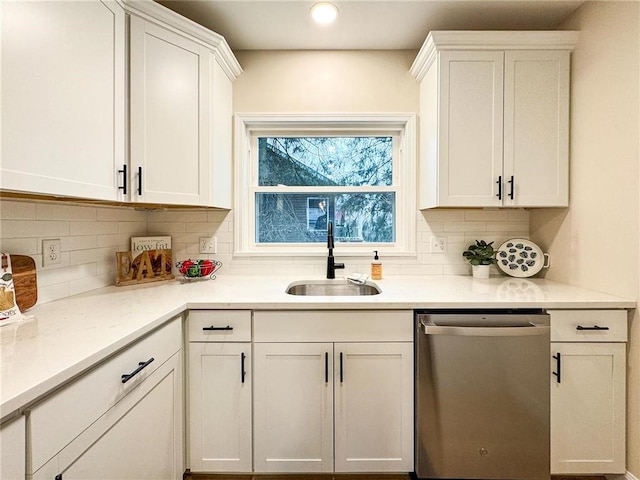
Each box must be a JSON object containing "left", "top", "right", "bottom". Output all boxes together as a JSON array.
[{"left": 234, "top": 113, "right": 417, "bottom": 256}]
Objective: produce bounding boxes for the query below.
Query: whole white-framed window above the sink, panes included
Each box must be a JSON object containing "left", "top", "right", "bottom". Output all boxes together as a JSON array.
[{"left": 235, "top": 115, "right": 416, "bottom": 255}]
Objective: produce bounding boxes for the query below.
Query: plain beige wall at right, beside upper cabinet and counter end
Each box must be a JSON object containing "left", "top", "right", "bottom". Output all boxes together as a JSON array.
[{"left": 531, "top": 2, "right": 640, "bottom": 477}]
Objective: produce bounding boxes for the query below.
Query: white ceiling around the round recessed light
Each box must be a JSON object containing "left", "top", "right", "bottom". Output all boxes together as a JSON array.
[{"left": 156, "top": 0, "right": 584, "bottom": 50}]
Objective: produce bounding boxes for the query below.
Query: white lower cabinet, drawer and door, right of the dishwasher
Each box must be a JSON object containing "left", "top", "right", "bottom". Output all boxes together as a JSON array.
[{"left": 550, "top": 310, "right": 627, "bottom": 475}]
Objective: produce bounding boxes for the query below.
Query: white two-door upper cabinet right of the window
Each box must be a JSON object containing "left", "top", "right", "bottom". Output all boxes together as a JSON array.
[{"left": 411, "top": 32, "right": 577, "bottom": 208}]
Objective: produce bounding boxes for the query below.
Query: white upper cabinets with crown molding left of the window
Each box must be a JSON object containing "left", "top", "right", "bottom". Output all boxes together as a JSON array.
[{"left": 0, "top": 0, "right": 242, "bottom": 208}]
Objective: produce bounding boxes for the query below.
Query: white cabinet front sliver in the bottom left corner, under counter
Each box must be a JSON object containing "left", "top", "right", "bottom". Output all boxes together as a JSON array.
[{"left": 0, "top": 415, "right": 27, "bottom": 480}]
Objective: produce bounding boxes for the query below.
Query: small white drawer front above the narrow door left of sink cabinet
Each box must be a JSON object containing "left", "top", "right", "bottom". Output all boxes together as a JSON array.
[{"left": 188, "top": 310, "right": 251, "bottom": 342}]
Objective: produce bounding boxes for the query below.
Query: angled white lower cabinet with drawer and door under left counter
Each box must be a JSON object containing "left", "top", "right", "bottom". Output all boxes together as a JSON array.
[{"left": 28, "top": 318, "right": 184, "bottom": 480}]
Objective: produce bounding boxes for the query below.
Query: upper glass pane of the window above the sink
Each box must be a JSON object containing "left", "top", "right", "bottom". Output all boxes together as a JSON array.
[{"left": 258, "top": 137, "right": 393, "bottom": 186}]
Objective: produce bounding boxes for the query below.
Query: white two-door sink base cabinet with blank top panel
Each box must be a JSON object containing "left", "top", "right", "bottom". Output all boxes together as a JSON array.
[{"left": 254, "top": 311, "right": 413, "bottom": 472}]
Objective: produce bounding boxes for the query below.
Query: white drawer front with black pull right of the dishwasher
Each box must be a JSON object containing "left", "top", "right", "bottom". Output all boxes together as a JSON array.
[{"left": 548, "top": 310, "right": 627, "bottom": 342}]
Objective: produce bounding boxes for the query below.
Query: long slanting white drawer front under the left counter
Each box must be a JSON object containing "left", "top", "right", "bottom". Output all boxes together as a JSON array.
[{"left": 30, "top": 318, "right": 182, "bottom": 472}]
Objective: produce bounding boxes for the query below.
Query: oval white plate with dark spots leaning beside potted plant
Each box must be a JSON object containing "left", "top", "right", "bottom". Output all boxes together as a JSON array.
[{"left": 496, "top": 238, "right": 548, "bottom": 278}]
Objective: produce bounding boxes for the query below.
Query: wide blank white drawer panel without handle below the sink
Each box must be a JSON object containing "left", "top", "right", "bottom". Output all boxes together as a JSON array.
[{"left": 253, "top": 310, "right": 413, "bottom": 342}]
